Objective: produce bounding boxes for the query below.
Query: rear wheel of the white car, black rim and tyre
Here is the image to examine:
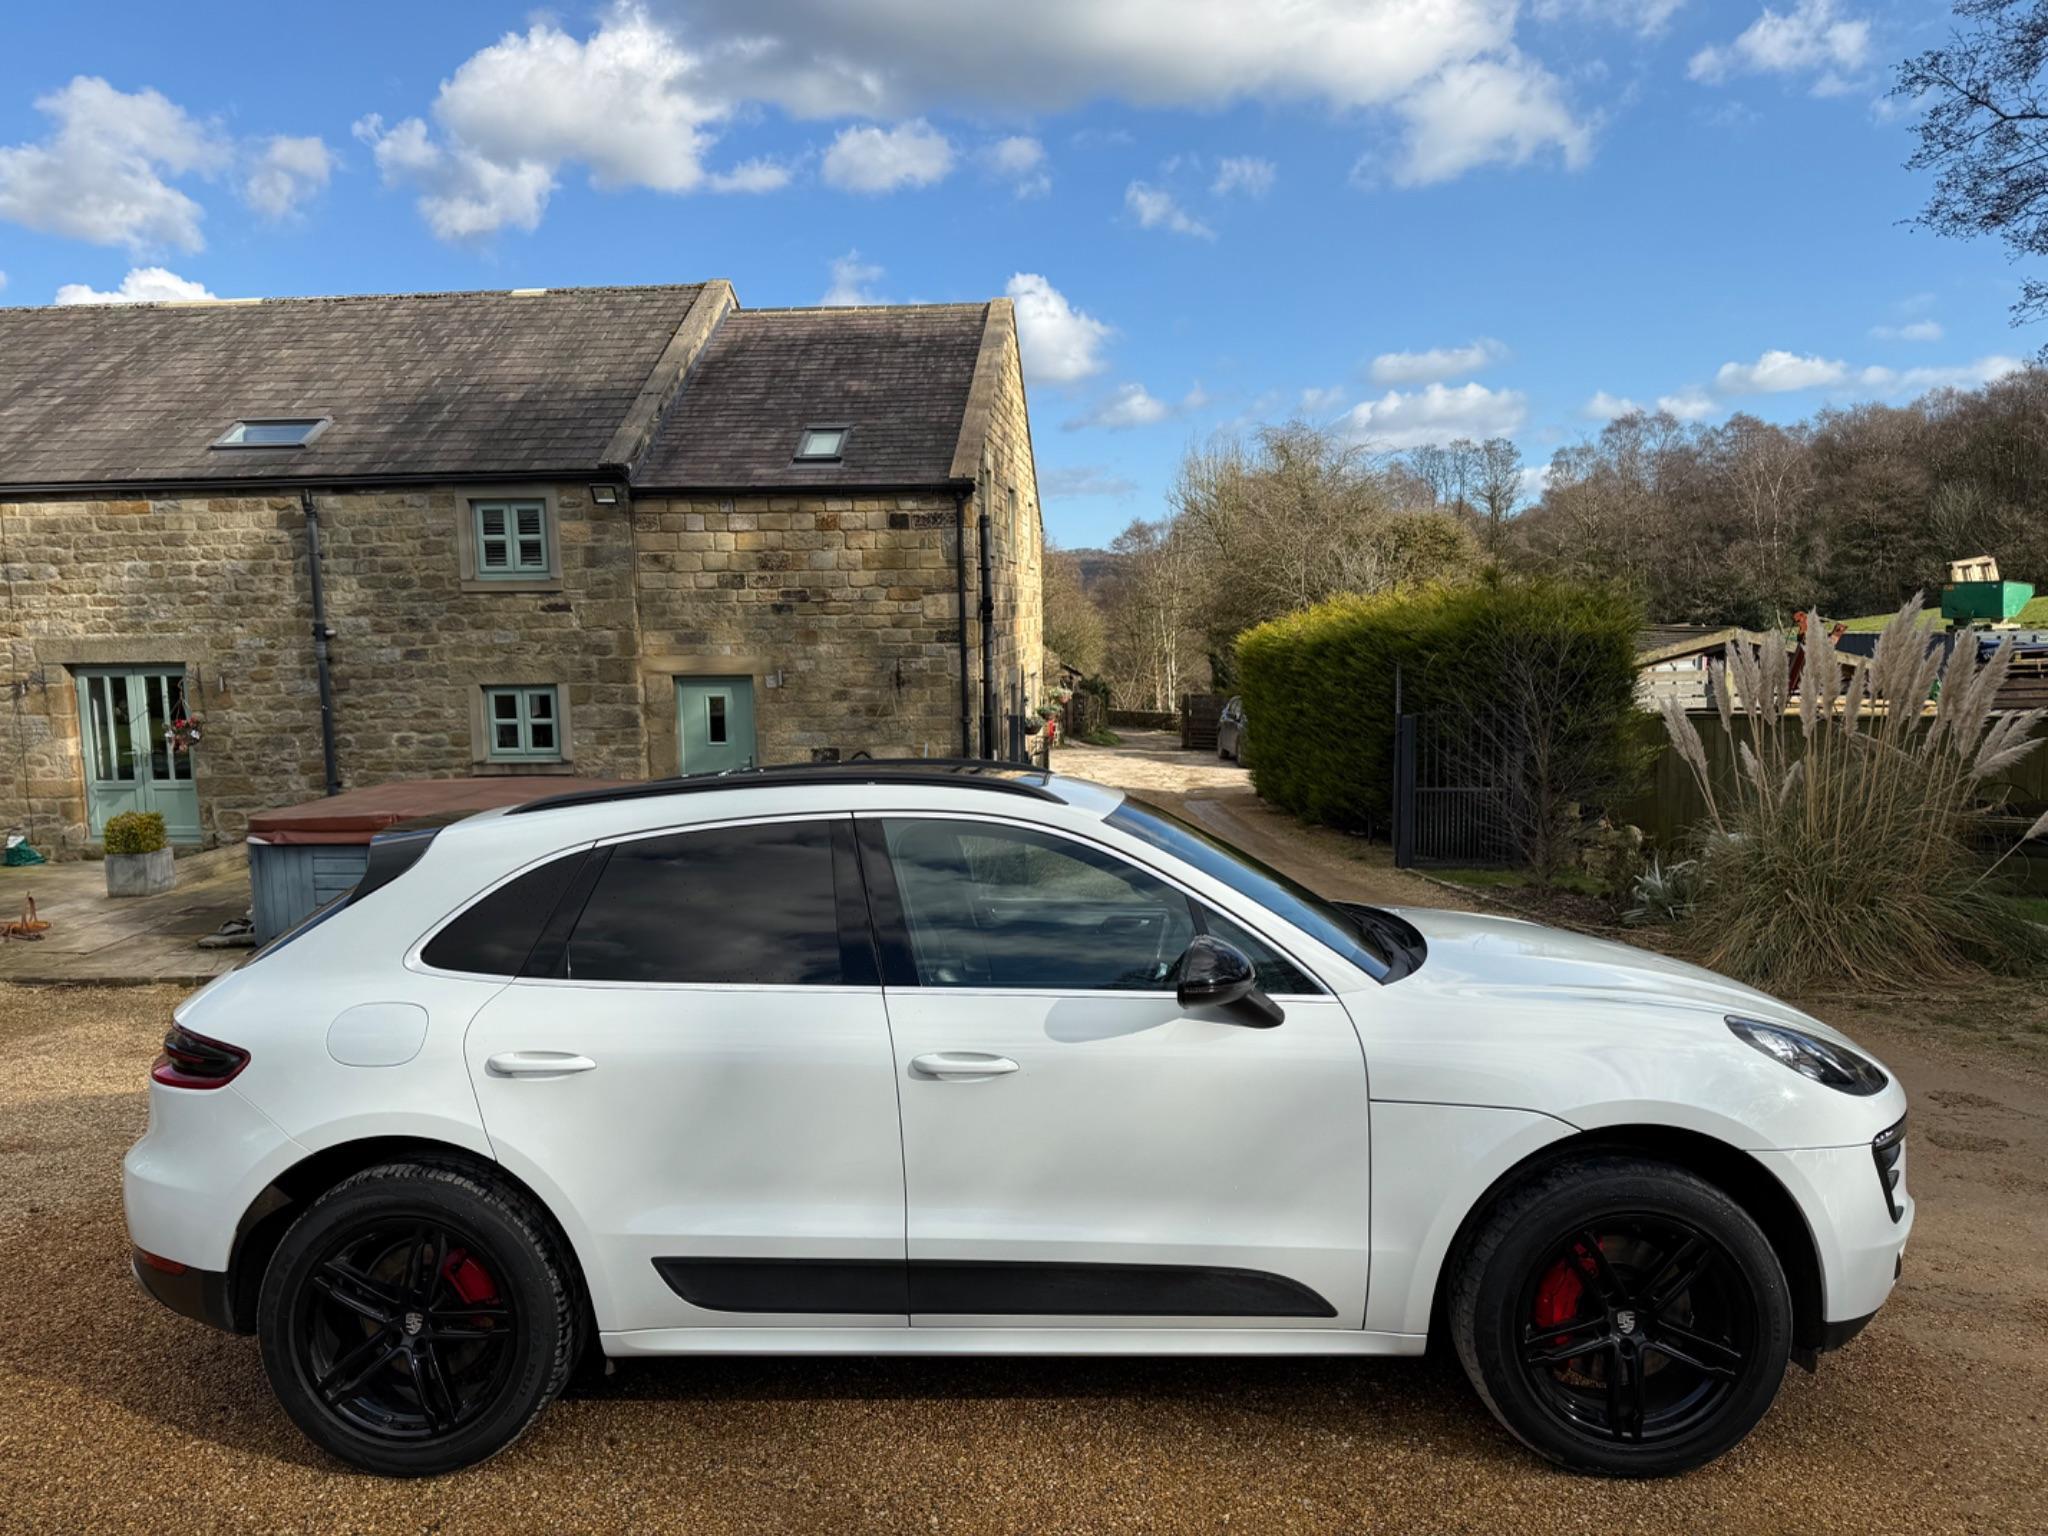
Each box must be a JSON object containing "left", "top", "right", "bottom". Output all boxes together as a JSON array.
[{"left": 256, "top": 1163, "right": 580, "bottom": 1477}]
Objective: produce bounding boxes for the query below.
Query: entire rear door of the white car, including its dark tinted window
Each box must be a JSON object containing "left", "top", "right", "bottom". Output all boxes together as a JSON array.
[{"left": 464, "top": 817, "right": 909, "bottom": 1331}]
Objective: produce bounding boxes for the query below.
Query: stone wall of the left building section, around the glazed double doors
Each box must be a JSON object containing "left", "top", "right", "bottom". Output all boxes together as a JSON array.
[{"left": 0, "top": 485, "right": 643, "bottom": 852}]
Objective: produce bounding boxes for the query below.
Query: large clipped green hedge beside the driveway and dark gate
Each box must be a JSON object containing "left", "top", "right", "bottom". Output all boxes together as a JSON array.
[{"left": 1237, "top": 575, "right": 1642, "bottom": 836}]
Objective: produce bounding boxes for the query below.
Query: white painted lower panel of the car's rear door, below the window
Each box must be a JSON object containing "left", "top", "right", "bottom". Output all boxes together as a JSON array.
[{"left": 465, "top": 981, "right": 907, "bottom": 1329}]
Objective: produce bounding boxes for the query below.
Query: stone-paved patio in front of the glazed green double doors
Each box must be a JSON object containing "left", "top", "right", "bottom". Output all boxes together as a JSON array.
[{"left": 0, "top": 844, "right": 250, "bottom": 987}]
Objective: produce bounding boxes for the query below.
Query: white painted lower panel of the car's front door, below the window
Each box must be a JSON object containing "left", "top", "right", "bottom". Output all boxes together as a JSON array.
[{"left": 889, "top": 989, "right": 1370, "bottom": 1327}]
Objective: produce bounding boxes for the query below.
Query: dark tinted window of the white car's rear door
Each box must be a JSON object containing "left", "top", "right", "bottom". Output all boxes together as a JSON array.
[{"left": 565, "top": 821, "right": 851, "bottom": 987}]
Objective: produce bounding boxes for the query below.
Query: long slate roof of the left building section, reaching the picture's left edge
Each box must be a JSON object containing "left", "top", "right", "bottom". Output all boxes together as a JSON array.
[{"left": 0, "top": 283, "right": 705, "bottom": 485}]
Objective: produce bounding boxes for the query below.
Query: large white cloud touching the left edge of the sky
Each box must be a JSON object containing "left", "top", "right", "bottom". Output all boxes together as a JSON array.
[{"left": 0, "top": 76, "right": 231, "bottom": 252}]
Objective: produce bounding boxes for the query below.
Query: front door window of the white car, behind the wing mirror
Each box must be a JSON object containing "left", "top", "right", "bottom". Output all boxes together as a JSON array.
[{"left": 885, "top": 819, "right": 1194, "bottom": 991}]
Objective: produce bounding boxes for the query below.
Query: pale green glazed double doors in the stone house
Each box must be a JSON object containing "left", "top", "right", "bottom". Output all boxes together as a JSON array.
[{"left": 76, "top": 666, "right": 199, "bottom": 842}]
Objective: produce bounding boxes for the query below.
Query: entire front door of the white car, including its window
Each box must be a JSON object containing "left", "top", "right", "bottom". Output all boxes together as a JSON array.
[{"left": 862, "top": 817, "right": 1370, "bottom": 1327}]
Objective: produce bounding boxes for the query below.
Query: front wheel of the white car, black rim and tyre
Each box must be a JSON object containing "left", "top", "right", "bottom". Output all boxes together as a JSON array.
[{"left": 1448, "top": 1157, "right": 1792, "bottom": 1477}]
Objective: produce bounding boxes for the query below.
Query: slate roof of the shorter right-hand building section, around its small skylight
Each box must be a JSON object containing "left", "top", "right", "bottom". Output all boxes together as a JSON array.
[{"left": 633, "top": 303, "right": 989, "bottom": 489}]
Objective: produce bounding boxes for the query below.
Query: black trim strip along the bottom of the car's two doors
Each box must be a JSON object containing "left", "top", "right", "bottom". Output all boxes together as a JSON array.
[{"left": 653, "top": 1260, "right": 1337, "bottom": 1317}]
